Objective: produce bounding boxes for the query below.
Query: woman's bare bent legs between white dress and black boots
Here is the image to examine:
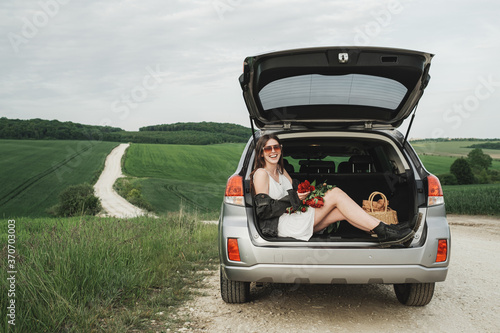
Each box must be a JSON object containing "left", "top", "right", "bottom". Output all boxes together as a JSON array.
[{"left": 314, "top": 187, "right": 380, "bottom": 231}]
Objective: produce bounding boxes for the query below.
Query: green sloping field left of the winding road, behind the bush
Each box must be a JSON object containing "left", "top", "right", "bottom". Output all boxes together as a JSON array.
[{"left": 0, "top": 140, "right": 117, "bottom": 218}]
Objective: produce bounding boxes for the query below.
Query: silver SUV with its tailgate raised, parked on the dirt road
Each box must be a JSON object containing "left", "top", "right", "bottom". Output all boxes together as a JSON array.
[{"left": 219, "top": 47, "right": 451, "bottom": 306}]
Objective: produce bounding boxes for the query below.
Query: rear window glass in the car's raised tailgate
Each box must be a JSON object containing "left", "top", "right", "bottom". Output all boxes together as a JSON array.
[{"left": 259, "top": 74, "right": 408, "bottom": 110}]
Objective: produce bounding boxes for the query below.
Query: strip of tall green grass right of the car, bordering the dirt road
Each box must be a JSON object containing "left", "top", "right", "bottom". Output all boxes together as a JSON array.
[{"left": 443, "top": 184, "right": 500, "bottom": 215}]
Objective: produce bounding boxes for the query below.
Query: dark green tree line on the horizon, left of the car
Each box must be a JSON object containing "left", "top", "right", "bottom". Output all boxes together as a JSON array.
[{"left": 0, "top": 117, "right": 251, "bottom": 145}]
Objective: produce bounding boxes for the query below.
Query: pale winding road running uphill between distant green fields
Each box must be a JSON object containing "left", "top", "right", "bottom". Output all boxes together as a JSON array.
[{"left": 94, "top": 143, "right": 146, "bottom": 218}]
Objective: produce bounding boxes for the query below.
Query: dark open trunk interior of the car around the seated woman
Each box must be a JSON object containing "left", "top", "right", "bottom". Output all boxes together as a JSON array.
[{"left": 249, "top": 132, "right": 417, "bottom": 242}]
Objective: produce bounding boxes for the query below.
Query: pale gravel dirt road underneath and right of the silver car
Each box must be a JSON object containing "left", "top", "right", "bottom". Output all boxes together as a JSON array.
[{"left": 179, "top": 216, "right": 500, "bottom": 333}]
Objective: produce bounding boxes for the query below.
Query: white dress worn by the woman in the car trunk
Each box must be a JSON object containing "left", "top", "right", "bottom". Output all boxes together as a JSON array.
[{"left": 264, "top": 169, "right": 314, "bottom": 241}]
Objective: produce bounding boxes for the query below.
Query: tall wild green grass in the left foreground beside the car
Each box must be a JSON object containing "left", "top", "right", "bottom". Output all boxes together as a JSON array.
[{"left": 0, "top": 214, "right": 217, "bottom": 332}]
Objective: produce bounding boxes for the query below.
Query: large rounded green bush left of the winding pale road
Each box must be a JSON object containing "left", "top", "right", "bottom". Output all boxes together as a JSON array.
[{"left": 51, "top": 183, "right": 101, "bottom": 217}]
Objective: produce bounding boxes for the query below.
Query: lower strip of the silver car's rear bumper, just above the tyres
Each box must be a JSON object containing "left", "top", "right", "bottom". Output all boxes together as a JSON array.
[{"left": 221, "top": 264, "right": 448, "bottom": 284}]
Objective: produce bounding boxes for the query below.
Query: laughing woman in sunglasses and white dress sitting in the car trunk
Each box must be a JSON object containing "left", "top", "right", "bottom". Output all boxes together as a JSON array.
[{"left": 250, "top": 134, "right": 414, "bottom": 244}]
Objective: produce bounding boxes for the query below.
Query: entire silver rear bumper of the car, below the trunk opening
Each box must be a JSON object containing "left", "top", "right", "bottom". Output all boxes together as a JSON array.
[{"left": 219, "top": 205, "right": 451, "bottom": 284}]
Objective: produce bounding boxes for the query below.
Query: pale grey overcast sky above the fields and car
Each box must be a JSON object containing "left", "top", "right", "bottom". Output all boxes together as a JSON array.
[{"left": 0, "top": 0, "right": 500, "bottom": 138}]
